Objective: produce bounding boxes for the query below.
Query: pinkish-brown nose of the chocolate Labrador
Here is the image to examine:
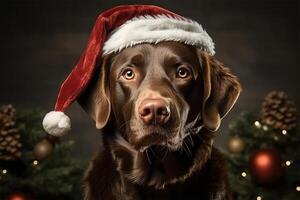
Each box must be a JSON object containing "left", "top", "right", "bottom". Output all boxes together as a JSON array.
[{"left": 138, "top": 99, "right": 170, "bottom": 124}]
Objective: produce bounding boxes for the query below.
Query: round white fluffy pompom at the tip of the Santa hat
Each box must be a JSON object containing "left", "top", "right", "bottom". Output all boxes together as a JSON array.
[{"left": 43, "top": 111, "right": 71, "bottom": 137}]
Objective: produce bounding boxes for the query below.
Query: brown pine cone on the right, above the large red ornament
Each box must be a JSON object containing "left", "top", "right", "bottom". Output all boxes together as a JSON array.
[{"left": 261, "top": 91, "right": 298, "bottom": 130}]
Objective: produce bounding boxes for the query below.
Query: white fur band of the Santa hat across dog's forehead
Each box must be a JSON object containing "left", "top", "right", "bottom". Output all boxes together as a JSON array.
[{"left": 103, "top": 15, "right": 215, "bottom": 55}]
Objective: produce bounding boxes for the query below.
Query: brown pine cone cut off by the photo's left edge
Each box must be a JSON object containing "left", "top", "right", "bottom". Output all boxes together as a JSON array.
[{"left": 0, "top": 105, "right": 22, "bottom": 160}]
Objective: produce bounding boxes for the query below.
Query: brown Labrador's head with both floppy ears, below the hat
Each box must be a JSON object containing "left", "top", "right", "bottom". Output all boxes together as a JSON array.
[{"left": 80, "top": 42, "right": 240, "bottom": 151}]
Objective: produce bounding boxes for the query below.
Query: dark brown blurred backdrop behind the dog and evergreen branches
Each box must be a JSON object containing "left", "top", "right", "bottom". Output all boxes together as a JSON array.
[{"left": 0, "top": 0, "right": 300, "bottom": 158}]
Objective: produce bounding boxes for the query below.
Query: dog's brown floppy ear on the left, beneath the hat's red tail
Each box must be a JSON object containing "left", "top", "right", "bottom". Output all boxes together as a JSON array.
[{"left": 78, "top": 56, "right": 111, "bottom": 129}]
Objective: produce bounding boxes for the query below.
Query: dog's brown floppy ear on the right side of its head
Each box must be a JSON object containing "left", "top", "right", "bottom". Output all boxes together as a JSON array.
[{"left": 197, "top": 50, "right": 241, "bottom": 131}]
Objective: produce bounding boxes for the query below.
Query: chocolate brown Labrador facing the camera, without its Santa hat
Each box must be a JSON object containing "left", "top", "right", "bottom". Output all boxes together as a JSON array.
[{"left": 79, "top": 42, "right": 241, "bottom": 200}]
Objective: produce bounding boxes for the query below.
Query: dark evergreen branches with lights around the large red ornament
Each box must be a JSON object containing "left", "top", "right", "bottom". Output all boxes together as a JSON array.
[{"left": 224, "top": 113, "right": 300, "bottom": 200}]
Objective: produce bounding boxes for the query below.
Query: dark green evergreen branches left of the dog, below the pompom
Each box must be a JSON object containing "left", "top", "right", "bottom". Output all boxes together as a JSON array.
[{"left": 0, "top": 110, "right": 86, "bottom": 200}]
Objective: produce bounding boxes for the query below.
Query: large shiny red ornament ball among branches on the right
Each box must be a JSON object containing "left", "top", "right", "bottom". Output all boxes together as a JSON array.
[{"left": 249, "top": 149, "right": 284, "bottom": 186}]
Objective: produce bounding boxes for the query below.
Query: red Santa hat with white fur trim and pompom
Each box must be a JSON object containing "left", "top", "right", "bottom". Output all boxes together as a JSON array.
[{"left": 43, "top": 5, "right": 215, "bottom": 136}]
